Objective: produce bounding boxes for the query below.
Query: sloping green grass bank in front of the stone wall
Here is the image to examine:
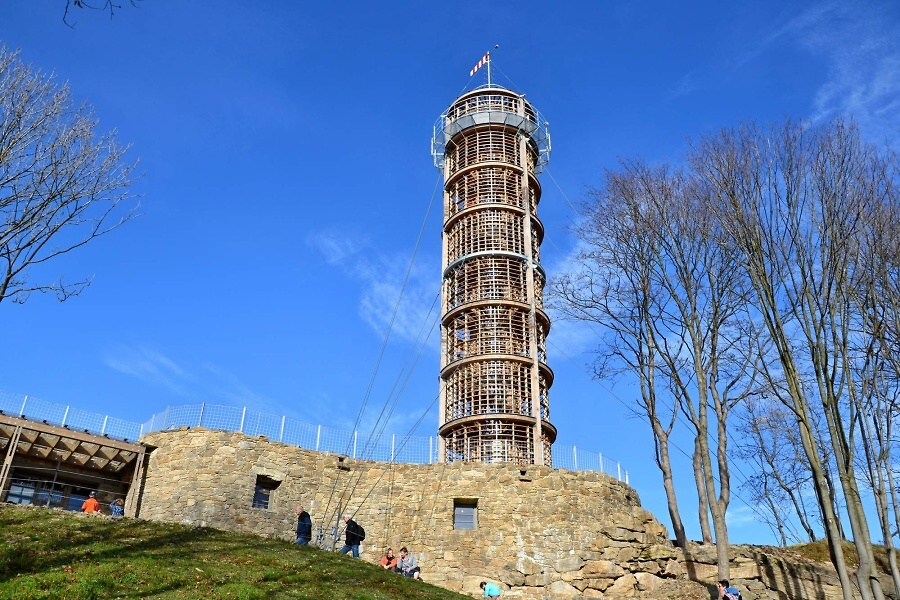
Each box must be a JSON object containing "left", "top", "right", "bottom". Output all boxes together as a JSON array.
[{"left": 0, "top": 505, "right": 467, "bottom": 600}]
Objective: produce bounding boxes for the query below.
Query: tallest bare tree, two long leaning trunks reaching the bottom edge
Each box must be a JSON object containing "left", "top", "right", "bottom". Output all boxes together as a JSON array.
[{"left": 690, "top": 121, "right": 884, "bottom": 600}]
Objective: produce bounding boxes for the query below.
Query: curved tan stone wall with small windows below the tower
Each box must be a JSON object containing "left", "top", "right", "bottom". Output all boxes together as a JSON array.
[{"left": 138, "top": 429, "right": 896, "bottom": 600}]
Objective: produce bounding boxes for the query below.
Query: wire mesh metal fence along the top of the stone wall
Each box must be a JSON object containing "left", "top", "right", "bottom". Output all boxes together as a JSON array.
[{"left": 0, "top": 391, "right": 628, "bottom": 483}]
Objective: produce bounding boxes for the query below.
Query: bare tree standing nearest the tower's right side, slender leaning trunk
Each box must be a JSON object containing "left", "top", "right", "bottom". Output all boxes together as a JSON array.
[{"left": 549, "top": 166, "right": 687, "bottom": 548}]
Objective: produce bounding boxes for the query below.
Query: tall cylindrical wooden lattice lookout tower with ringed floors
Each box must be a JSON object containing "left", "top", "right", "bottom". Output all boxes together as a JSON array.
[{"left": 432, "top": 84, "right": 556, "bottom": 466}]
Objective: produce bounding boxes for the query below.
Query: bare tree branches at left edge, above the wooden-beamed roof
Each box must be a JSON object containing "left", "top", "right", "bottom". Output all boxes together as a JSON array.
[{"left": 0, "top": 48, "right": 137, "bottom": 302}]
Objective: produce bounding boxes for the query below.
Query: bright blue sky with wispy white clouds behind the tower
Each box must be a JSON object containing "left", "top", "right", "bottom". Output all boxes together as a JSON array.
[{"left": 0, "top": 0, "right": 900, "bottom": 542}]
